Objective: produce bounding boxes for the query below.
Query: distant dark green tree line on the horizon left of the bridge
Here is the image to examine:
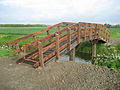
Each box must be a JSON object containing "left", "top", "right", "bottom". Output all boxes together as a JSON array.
[{"left": 0, "top": 24, "right": 47, "bottom": 27}]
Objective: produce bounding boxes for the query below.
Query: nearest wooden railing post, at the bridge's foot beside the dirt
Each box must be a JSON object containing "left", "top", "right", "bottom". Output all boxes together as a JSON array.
[{"left": 38, "top": 42, "right": 44, "bottom": 67}]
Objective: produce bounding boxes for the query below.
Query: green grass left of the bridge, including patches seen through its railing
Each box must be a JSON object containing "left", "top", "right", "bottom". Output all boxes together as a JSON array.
[{"left": 0, "top": 27, "right": 56, "bottom": 46}]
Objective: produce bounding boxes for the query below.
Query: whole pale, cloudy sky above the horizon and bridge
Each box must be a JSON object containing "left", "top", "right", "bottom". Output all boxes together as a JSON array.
[{"left": 0, "top": 0, "right": 120, "bottom": 24}]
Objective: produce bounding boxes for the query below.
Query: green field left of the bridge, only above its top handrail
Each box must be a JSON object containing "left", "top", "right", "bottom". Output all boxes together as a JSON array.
[{"left": 0, "top": 27, "right": 44, "bottom": 46}]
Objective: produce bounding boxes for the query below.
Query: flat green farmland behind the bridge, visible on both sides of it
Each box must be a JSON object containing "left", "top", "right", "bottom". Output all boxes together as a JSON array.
[{"left": 0, "top": 27, "right": 120, "bottom": 46}]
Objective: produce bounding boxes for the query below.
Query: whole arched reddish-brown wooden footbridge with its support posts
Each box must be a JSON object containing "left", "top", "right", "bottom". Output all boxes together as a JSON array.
[{"left": 7, "top": 22, "right": 111, "bottom": 67}]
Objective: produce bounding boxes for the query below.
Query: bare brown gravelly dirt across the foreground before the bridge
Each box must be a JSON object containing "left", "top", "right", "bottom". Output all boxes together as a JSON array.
[{"left": 0, "top": 58, "right": 120, "bottom": 90}]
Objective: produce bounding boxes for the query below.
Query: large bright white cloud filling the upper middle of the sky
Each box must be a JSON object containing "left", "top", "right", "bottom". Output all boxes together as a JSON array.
[{"left": 0, "top": 0, "right": 119, "bottom": 23}]
